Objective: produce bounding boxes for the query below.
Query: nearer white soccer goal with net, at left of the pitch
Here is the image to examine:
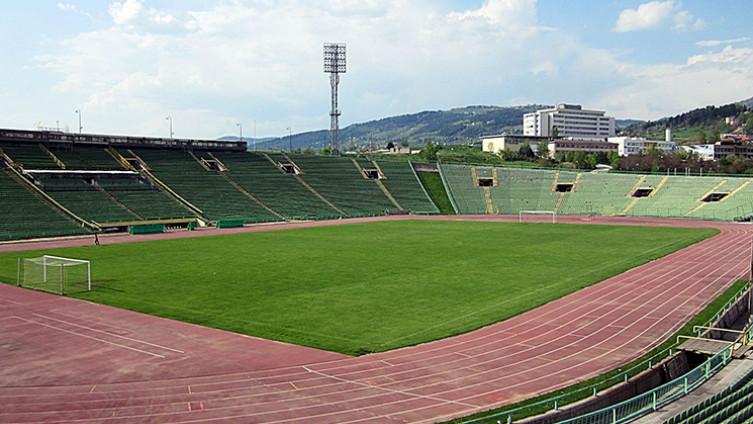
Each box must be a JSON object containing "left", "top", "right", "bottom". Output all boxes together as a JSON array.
[{"left": 17, "top": 255, "right": 92, "bottom": 294}]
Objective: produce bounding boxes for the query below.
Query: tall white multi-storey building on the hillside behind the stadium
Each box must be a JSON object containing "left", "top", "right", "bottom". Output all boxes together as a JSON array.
[{"left": 523, "top": 103, "right": 615, "bottom": 139}]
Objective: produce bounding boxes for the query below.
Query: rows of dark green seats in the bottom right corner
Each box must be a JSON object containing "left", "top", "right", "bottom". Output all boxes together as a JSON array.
[{"left": 664, "top": 371, "right": 753, "bottom": 424}]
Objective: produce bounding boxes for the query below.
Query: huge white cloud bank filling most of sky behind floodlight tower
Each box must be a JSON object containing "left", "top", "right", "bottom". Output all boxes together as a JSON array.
[{"left": 27, "top": 0, "right": 753, "bottom": 137}]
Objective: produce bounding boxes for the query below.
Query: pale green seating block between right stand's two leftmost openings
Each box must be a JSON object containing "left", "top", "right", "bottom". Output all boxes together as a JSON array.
[{"left": 492, "top": 168, "right": 557, "bottom": 214}]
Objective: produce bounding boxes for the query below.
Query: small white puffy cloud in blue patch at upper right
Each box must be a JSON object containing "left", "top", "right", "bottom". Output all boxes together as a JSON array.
[{"left": 613, "top": 0, "right": 706, "bottom": 32}]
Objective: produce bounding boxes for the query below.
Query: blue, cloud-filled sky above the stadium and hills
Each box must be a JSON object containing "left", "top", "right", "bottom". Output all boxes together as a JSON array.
[{"left": 0, "top": 0, "right": 753, "bottom": 138}]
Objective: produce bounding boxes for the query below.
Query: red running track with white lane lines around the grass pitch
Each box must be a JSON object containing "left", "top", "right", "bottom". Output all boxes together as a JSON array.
[{"left": 0, "top": 216, "right": 751, "bottom": 423}]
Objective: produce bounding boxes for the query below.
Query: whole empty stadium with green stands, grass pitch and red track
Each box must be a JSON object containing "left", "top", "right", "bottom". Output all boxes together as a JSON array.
[{"left": 0, "top": 126, "right": 753, "bottom": 423}]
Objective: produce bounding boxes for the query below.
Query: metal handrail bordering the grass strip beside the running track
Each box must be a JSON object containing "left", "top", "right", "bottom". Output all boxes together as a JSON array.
[{"left": 462, "top": 281, "right": 753, "bottom": 424}]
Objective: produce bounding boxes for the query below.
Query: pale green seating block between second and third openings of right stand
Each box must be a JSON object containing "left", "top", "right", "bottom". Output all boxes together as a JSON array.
[{"left": 557, "top": 172, "right": 640, "bottom": 215}]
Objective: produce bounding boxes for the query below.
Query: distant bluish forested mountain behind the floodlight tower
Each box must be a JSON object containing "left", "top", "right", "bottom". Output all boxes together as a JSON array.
[{"left": 247, "top": 105, "right": 547, "bottom": 149}]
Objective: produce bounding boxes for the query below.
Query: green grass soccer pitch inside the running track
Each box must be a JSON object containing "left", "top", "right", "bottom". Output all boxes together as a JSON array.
[{"left": 0, "top": 221, "right": 716, "bottom": 354}]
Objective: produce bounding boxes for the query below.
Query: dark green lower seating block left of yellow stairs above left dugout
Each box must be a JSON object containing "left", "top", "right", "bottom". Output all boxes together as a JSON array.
[{"left": 97, "top": 176, "right": 195, "bottom": 220}]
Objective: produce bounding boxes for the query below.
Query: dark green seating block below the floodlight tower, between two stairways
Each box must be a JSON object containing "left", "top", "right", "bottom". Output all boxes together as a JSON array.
[{"left": 291, "top": 155, "right": 396, "bottom": 216}]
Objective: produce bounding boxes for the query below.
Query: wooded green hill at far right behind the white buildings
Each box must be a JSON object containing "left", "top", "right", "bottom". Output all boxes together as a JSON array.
[{"left": 621, "top": 98, "right": 753, "bottom": 144}]
